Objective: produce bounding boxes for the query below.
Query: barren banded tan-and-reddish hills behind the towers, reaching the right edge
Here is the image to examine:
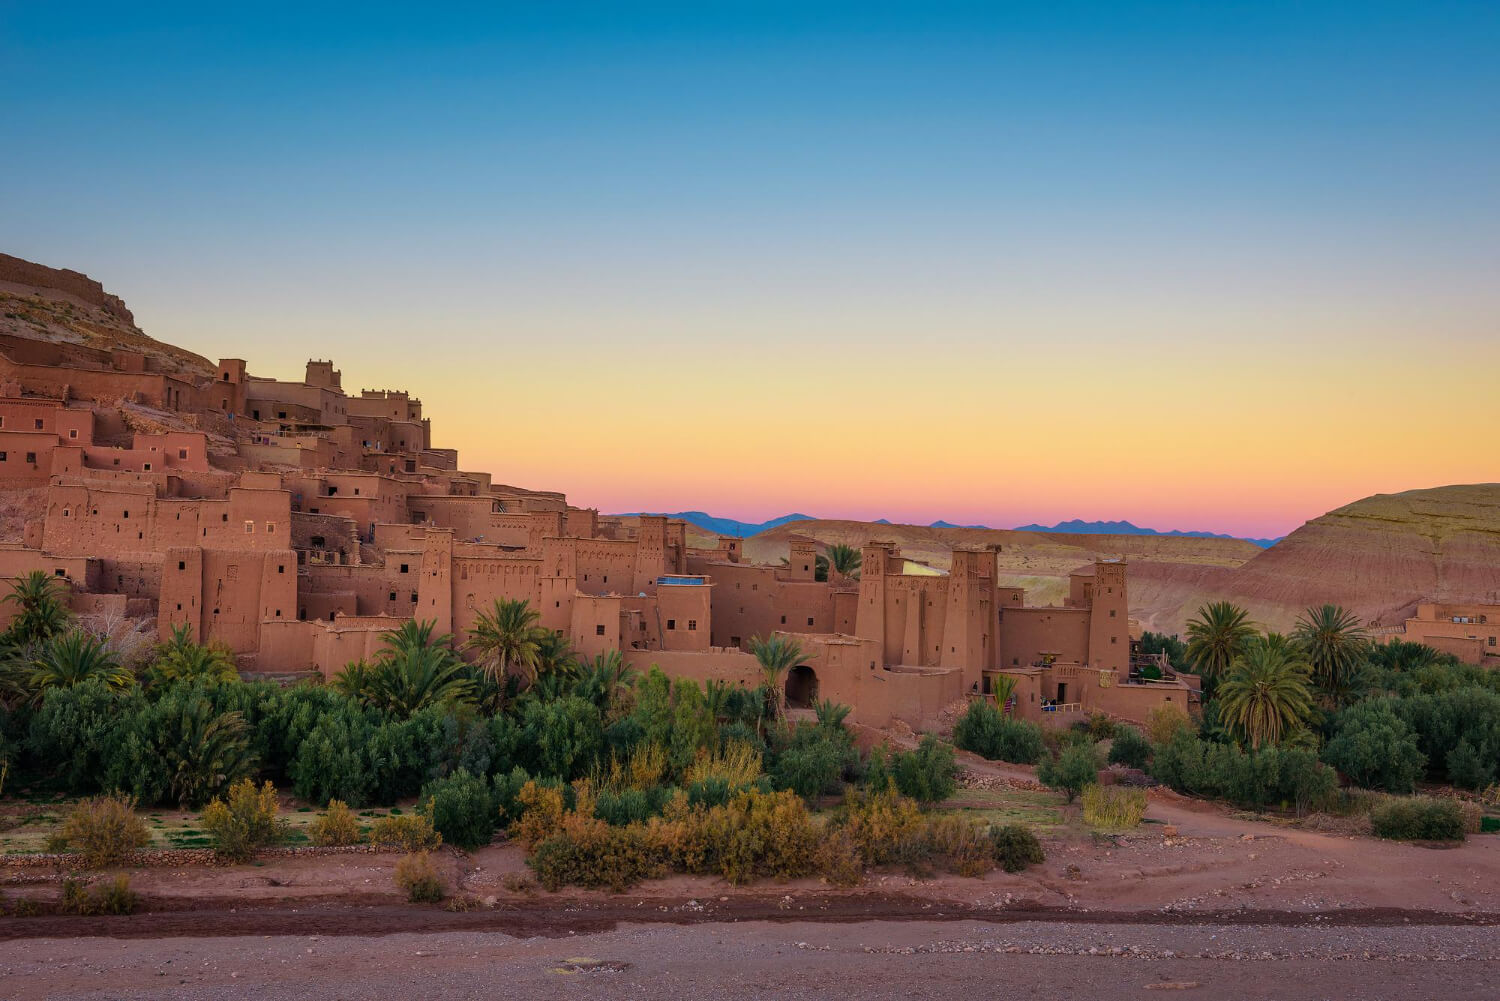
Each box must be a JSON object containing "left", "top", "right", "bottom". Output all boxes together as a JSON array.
[{"left": 746, "top": 483, "right": 1500, "bottom": 632}]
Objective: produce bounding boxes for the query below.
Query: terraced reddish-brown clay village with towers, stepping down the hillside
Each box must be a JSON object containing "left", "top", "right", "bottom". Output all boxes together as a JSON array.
[{"left": 0, "top": 351, "right": 1188, "bottom": 726}]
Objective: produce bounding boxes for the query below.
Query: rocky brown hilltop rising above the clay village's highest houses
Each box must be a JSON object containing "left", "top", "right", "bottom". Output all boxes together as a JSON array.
[{"left": 0, "top": 254, "right": 215, "bottom": 377}]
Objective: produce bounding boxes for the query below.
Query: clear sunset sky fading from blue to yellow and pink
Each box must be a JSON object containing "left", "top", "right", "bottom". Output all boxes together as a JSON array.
[{"left": 0, "top": 0, "right": 1500, "bottom": 536}]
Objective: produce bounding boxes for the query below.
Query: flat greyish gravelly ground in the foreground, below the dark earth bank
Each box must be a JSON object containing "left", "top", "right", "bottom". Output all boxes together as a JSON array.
[{"left": 0, "top": 921, "right": 1500, "bottom": 1001}]
